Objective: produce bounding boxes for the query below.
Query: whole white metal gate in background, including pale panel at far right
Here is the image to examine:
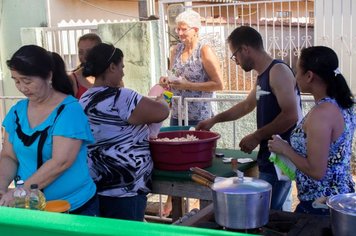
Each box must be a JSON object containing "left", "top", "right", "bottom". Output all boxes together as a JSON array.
[{"left": 159, "top": 0, "right": 356, "bottom": 94}]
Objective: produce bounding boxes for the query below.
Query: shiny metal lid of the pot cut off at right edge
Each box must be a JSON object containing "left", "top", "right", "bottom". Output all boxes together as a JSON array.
[{"left": 326, "top": 193, "right": 356, "bottom": 216}]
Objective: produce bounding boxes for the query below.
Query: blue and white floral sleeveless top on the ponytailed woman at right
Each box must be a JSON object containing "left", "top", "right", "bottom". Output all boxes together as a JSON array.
[{"left": 291, "top": 97, "right": 356, "bottom": 201}]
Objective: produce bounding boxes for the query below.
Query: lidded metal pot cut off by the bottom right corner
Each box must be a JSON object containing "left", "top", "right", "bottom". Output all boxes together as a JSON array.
[{"left": 326, "top": 193, "right": 356, "bottom": 236}]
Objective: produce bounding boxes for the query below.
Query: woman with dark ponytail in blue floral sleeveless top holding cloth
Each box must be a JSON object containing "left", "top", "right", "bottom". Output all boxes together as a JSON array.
[{"left": 268, "top": 46, "right": 356, "bottom": 214}]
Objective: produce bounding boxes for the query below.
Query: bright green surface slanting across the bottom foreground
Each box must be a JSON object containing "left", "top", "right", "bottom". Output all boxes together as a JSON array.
[{"left": 0, "top": 207, "right": 253, "bottom": 236}]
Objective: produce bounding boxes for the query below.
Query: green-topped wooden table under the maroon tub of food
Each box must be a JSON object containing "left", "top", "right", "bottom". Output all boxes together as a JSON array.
[{"left": 152, "top": 149, "right": 257, "bottom": 221}]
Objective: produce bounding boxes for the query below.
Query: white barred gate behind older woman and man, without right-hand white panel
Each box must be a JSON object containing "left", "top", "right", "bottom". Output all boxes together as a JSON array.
[{"left": 159, "top": 0, "right": 314, "bottom": 91}]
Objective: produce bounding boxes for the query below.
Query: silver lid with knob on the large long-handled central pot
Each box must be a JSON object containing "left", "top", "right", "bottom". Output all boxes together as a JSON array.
[{"left": 212, "top": 177, "right": 272, "bottom": 194}]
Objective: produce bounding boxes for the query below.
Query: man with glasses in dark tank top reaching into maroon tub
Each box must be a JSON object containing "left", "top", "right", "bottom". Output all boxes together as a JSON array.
[{"left": 196, "top": 26, "right": 302, "bottom": 210}]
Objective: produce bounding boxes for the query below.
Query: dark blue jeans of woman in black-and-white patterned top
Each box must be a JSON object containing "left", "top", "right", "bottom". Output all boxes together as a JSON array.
[{"left": 99, "top": 194, "right": 147, "bottom": 221}]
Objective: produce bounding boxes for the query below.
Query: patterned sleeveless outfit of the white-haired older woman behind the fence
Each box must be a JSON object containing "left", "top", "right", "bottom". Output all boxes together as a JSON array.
[{"left": 172, "top": 42, "right": 213, "bottom": 121}]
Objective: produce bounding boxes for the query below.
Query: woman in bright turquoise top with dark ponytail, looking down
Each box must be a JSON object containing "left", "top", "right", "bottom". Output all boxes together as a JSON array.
[{"left": 0, "top": 45, "right": 99, "bottom": 215}]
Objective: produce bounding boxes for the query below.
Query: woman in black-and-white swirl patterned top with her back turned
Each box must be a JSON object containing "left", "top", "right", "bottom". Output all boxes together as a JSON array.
[{"left": 80, "top": 43, "right": 169, "bottom": 221}]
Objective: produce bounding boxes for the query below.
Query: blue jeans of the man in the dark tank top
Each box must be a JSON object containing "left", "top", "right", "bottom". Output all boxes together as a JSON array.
[{"left": 259, "top": 172, "right": 291, "bottom": 210}]
